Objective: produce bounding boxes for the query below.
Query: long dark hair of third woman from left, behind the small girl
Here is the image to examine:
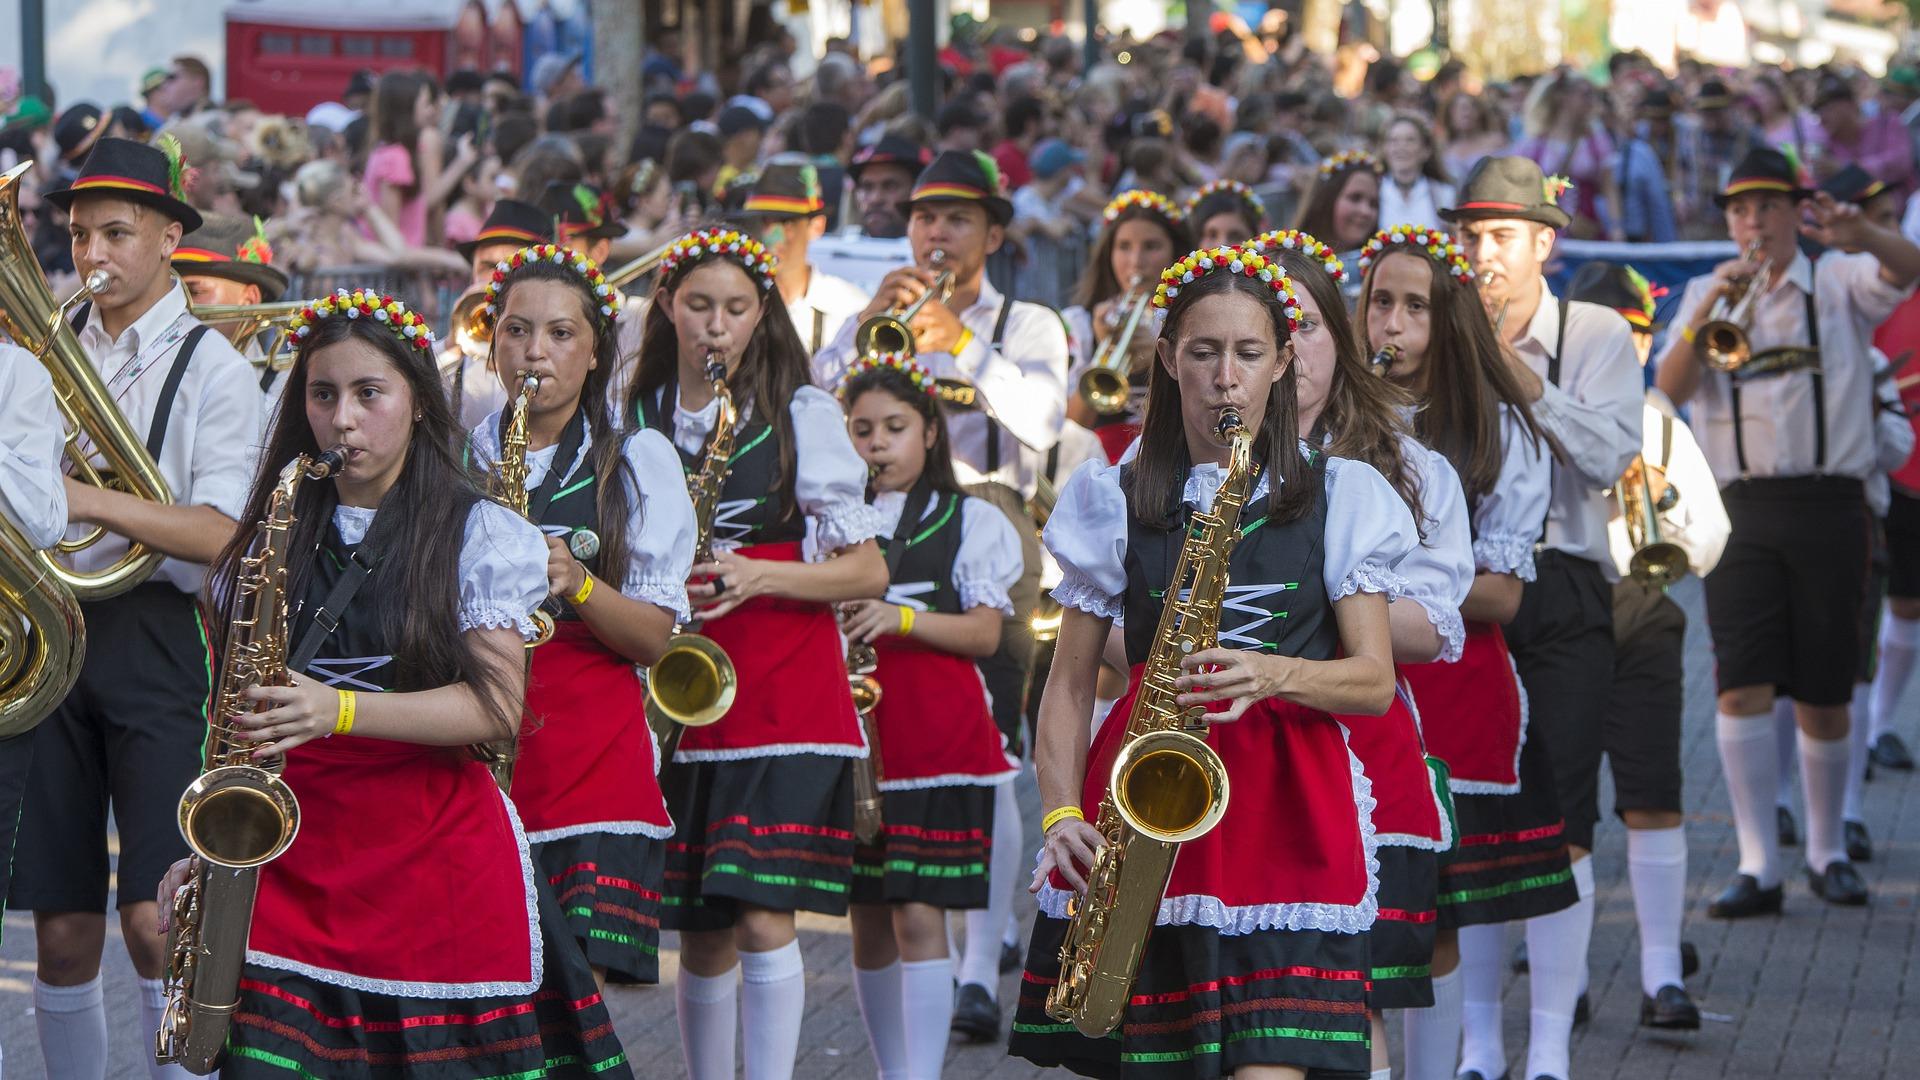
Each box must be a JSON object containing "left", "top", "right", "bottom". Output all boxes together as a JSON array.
[{"left": 620, "top": 256, "right": 814, "bottom": 519}]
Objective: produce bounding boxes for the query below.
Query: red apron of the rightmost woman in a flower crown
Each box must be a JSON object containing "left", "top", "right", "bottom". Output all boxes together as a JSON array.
[{"left": 1400, "top": 621, "right": 1526, "bottom": 796}]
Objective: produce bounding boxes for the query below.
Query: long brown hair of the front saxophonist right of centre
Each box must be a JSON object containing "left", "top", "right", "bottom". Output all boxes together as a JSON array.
[{"left": 1121, "top": 273, "right": 1315, "bottom": 528}]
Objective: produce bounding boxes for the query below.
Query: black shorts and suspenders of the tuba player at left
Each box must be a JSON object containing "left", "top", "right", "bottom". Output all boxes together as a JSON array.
[{"left": 0, "top": 302, "right": 213, "bottom": 913}]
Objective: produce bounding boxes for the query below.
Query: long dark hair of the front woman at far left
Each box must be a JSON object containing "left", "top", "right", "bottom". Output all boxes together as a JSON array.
[{"left": 205, "top": 317, "right": 520, "bottom": 736}]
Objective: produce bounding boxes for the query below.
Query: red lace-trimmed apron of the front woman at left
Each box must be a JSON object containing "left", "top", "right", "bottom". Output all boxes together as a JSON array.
[{"left": 248, "top": 736, "right": 540, "bottom": 997}]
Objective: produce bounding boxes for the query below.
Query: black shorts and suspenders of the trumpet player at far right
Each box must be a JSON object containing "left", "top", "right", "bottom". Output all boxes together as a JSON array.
[{"left": 1707, "top": 267, "right": 1870, "bottom": 705}]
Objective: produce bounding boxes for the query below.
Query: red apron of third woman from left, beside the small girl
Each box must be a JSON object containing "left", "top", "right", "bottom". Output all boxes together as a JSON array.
[{"left": 674, "top": 542, "right": 866, "bottom": 761}]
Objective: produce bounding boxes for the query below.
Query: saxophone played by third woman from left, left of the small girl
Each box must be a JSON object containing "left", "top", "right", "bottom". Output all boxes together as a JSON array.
[{"left": 647, "top": 348, "right": 739, "bottom": 759}]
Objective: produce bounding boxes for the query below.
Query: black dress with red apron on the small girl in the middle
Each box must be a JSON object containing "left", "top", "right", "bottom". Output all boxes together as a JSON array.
[{"left": 852, "top": 479, "right": 1018, "bottom": 909}]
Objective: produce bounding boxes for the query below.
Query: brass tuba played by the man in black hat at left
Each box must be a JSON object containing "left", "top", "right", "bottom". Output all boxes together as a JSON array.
[{"left": 0, "top": 161, "right": 173, "bottom": 600}]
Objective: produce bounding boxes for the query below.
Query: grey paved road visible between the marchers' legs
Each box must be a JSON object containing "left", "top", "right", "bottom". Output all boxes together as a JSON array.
[{"left": 0, "top": 584, "right": 1920, "bottom": 1080}]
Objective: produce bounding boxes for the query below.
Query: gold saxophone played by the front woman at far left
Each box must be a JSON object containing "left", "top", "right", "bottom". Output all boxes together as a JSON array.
[{"left": 154, "top": 448, "right": 346, "bottom": 1076}]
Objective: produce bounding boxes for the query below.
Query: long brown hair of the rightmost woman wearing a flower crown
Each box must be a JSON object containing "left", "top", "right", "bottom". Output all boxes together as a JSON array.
[{"left": 1357, "top": 250, "right": 1546, "bottom": 505}]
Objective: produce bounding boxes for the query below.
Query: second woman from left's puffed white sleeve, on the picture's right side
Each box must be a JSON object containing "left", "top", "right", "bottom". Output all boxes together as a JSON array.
[{"left": 620, "top": 429, "right": 699, "bottom": 623}]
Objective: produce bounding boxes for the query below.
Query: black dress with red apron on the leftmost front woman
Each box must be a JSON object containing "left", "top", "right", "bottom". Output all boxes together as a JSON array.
[{"left": 223, "top": 498, "right": 632, "bottom": 1080}]
